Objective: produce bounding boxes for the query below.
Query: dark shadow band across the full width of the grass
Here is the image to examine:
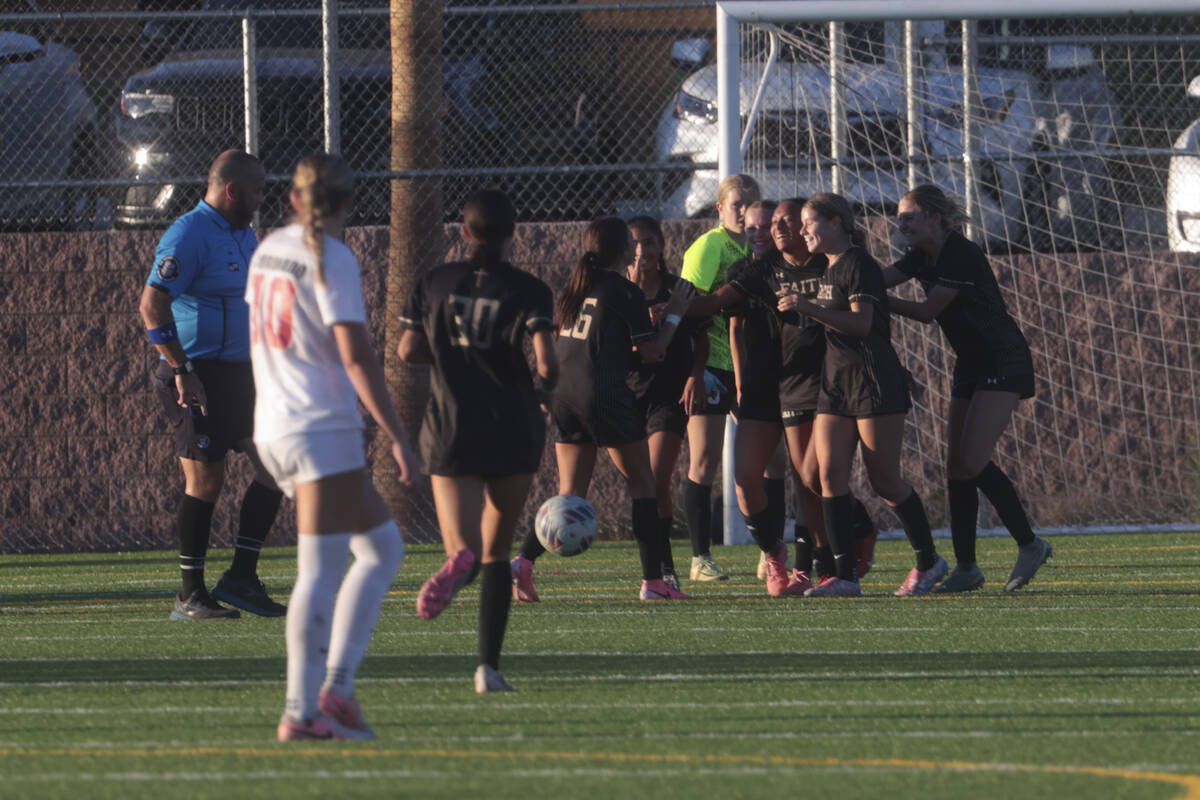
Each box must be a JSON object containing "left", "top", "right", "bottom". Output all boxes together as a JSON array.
[{"left": 0, "top": 650, "right": 1196, "bottom": 685}]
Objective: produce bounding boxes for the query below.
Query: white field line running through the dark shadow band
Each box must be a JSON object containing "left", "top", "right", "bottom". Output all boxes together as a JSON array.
[{"left": 0, "top": 666, "right": 1200, "bottom": 688}]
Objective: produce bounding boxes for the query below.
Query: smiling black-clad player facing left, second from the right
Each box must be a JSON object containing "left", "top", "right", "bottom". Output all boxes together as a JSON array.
[{"left": 779, "top": 193, "right": 947, "bottom": 597}]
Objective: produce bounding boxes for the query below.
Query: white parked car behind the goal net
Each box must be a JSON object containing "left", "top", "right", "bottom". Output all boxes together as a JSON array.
[{"left": 655, "top": 23, "right": 1120, "bottom": 247}]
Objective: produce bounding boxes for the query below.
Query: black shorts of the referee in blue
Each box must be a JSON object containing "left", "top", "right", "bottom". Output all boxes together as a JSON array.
[{"left": 154, "top": 359, "right": 254, "bottom": 463}]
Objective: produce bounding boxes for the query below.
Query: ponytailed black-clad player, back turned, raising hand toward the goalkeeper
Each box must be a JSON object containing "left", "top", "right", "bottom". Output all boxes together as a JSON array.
[{"left": 512, "top": 217, "right": 695, "bottom": 600}]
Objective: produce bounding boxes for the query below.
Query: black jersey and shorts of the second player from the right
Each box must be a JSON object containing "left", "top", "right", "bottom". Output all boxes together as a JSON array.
[{"left": 816, "top": 247, "right": 910, "bottom": 417}]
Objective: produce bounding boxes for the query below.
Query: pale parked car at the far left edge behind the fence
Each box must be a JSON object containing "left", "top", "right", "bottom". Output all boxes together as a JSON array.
[{"left": 0, "top": 0, "right": 104, "bottom": 230}]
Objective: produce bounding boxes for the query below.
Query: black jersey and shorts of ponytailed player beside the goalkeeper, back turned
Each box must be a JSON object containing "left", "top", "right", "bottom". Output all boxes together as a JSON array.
[{"left": 553, "top": 270, "right": 655, "bottom": 446}]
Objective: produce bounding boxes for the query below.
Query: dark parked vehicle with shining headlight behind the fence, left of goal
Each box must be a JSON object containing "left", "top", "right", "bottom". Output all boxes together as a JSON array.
[{"left": 115, "top": 0, "right": 596, "bottom": 227}]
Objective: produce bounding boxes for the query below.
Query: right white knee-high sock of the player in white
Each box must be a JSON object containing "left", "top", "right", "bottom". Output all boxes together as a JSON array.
[{"left": 325, "top": 519, "right": 404, "bottom": 697}]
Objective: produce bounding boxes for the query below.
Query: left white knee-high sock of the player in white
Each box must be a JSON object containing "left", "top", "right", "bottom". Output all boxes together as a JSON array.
[{"left": 286, "top": 534, "right": 350, "bottom": 720}]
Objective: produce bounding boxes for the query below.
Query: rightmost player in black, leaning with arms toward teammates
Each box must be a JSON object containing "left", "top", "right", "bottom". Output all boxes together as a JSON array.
[{"left": 883, "top": 185, "right": 1054, "bottom": 593}]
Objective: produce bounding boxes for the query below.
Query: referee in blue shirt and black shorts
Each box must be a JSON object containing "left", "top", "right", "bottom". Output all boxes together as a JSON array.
[{"left": 139, "top": 150, "right": 287, "bottom": 620}]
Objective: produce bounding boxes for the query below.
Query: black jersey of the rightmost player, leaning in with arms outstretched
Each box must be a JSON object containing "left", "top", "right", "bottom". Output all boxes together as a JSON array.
[{"left": 894, "top": 231, "right": 1033, "bottom": 377}]
